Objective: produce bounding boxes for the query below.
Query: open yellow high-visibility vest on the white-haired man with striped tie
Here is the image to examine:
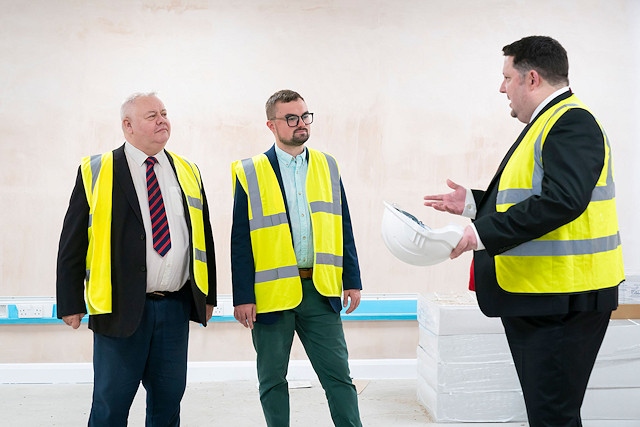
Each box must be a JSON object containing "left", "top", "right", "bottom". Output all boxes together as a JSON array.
[{"left": 80, "top": 151, "right": 209, "bottom": 315}]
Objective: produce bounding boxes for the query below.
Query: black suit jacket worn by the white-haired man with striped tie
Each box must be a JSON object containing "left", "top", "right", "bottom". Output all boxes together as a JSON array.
[{"left": 56, "top": 145, "right": 216, "bottom": 337}]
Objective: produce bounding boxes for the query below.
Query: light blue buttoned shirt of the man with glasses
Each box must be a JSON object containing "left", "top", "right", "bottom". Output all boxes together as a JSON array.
[{"left": 275, "top": 145, "right": 313, "bottom": 268}]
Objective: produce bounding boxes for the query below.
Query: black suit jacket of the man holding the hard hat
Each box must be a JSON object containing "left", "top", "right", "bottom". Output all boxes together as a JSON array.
[{"left": 473, "top": 91, "right": 618, "bottom": 317}]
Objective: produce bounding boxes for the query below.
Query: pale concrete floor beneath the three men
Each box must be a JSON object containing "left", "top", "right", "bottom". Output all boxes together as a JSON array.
[{"left": 0, "top": 380, "right": 637, "bottom": 427}]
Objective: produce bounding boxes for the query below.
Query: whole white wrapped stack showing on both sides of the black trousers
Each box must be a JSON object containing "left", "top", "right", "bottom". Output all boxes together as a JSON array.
[{"left": 417, "top": 292, "right": 640, "bottom": 425}]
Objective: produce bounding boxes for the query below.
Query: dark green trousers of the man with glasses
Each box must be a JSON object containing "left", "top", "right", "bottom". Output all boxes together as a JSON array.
[{"left": 252, "top": 279, "right": 362, "bottom": 427}]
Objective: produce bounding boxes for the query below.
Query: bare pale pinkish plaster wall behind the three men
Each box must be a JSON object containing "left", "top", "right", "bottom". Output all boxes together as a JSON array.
[{"left": 0, "top": 0, "right": 640, "bottom": 362}]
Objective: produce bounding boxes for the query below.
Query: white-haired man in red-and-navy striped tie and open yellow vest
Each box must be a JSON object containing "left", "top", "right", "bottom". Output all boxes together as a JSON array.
[{"left": 56, "top": 93, "right": 216, "bottom": 426}]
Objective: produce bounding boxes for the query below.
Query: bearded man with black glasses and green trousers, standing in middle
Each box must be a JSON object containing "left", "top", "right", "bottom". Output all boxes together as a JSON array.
[{"left": 231, "top": 90, "right": 362, "bottom": 427}]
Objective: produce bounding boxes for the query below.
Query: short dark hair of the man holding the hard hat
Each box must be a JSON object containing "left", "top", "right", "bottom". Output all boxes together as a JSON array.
[{"left": 502, "top": 36, "right": 569, "bottom": 86}]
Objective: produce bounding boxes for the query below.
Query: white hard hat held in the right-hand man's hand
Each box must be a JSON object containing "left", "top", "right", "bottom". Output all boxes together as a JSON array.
[{"left": 382, "top": 202, "right": 464, "bottom": 266}]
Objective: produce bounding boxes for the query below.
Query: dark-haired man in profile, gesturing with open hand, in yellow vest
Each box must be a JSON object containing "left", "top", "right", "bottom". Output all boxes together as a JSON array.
[{"left": 424, "top": 36, "right": 624, "bottom": 427}]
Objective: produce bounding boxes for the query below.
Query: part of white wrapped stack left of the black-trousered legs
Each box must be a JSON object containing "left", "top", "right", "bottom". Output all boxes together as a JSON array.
[{"left": 417, "top": 292, "right": 526, "bottom": 422}]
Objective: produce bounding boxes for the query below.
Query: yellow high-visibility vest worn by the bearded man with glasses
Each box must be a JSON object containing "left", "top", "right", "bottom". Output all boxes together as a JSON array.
[{"left": 231, "top": 149, "right": 343, "bottom": 313}]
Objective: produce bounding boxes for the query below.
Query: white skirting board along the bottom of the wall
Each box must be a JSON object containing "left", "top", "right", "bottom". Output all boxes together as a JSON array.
[{"left": 0, "top": 359, "right": 417, "bottom": 384}]
